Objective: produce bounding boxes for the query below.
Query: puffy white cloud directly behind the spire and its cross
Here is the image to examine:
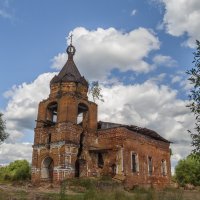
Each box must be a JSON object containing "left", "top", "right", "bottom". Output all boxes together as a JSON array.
[{"left": 52, "top": 27, "right": 160, "bottom": 79}]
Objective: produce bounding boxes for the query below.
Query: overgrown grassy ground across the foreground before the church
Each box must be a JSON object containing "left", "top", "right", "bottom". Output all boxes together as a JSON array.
[{"left": 0, "top": 179, "right": 200, "bottom": 200}]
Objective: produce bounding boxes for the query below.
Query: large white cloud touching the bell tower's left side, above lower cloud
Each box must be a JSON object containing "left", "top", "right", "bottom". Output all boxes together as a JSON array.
[{"left": 3, "top": 73, "right": 55, "bottom": 141}]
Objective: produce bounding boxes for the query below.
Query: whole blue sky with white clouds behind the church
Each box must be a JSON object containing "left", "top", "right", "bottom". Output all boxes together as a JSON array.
[{"left": 0, "top": 0, "right": 200, "bottom": 172}]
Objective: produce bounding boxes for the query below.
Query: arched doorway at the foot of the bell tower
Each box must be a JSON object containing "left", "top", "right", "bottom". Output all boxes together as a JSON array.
[{"left": 41, "top": 157, "right": 54, "bottom": 181}]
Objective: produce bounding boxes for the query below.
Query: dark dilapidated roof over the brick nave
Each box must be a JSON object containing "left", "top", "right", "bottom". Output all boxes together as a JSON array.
[{"left": 98, "top": 121, "right": 170, "bottom": 143}]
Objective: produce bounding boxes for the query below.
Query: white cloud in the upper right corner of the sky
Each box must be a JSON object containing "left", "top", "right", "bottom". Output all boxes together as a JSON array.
[{"left": 157, "top": 0, "right": 200, "bottom": 47}]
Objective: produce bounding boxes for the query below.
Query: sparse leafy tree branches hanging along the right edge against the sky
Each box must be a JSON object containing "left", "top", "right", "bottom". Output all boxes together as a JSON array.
[{"left": 186, "top": 40, "right": 200, "bottom": 154}]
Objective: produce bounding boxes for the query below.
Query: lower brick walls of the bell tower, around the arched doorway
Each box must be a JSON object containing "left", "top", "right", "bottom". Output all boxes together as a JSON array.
[{"left": 32, "top": 123, "right": 82, "bottom": 183}]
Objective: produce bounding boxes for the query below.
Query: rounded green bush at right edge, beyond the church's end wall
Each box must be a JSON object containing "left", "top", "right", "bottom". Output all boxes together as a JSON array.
[{"left": 175, "top": 155, "right": 200, "bottom": 186}]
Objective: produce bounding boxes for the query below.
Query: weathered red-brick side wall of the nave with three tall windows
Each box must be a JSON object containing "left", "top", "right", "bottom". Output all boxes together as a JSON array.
[{"left": 94, "top": 128, "right": 171, "bottom": 187}]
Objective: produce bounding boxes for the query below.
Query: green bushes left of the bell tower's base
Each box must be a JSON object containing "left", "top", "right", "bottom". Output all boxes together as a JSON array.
[{"left": 0, "top": 160, "right": 31, "bottom": 181}]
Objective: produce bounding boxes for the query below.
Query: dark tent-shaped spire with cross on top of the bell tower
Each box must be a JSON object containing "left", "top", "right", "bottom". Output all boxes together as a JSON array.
[{"left": 50, "top": 34, "right": 88, "bottom": 87}]
